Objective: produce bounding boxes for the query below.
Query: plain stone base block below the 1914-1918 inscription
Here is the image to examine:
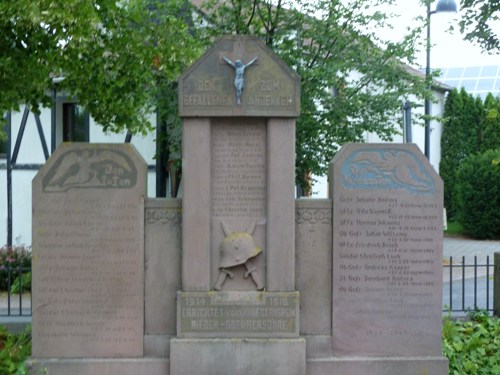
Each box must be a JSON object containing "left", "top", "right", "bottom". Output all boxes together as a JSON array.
[{"left": 170, "top": 338, "right": 306, "bottom": 375}]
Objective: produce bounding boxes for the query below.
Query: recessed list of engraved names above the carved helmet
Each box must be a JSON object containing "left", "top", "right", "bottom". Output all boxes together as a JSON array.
[{"left": 211, "top": 120, "right": 267, "bottom": 217}]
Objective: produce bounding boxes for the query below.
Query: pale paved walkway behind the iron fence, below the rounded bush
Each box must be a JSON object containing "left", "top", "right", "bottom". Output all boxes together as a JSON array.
[{"left": 443, "top": 237, "right": 500, "bottom": 281}]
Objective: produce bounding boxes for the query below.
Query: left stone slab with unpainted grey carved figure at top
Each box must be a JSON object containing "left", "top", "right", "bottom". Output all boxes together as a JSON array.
[{"left": 33, "top": 145, "right": 145, "bottom": 357}]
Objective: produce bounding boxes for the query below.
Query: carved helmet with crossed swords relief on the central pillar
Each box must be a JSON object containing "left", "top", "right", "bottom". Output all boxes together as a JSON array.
[{"left": 214, "top": 220, "right": 264, "bottom": 290}]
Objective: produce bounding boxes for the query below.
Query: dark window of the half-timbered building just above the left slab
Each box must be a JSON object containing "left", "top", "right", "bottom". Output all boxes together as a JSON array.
[{"left": 63, "top": 103, "right": 89, "bottom": 142}]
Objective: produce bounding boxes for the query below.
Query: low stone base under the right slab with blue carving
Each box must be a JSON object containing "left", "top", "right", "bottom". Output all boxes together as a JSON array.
[{"left": 307, "top": 357, "right": 448, "bottom": 375}]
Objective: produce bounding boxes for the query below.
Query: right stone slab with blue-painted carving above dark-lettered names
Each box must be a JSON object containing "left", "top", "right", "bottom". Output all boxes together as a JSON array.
[{"left": 332, "top": 146, "right": 442, "bottom": 355}]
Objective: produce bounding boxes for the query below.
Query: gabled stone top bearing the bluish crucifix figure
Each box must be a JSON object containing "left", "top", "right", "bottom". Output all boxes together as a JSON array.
[{"left": 179, "top": 35, "right": 300, "bottom": 117}]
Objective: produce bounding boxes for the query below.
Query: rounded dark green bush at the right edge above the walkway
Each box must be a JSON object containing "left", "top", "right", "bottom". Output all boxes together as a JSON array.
[{"left": 455, "top": 148, "right": 500, "bottom": 239}]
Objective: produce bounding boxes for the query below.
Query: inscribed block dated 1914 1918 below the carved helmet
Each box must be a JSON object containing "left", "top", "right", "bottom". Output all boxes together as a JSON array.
[{"left": 177, "top": 291, "right": 299, "bottom": 337}]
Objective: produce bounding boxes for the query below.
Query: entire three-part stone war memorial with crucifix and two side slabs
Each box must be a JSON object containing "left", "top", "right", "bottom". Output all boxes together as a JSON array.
[{"left": 29, "top": 36, "right": 448, "bottom": 375}]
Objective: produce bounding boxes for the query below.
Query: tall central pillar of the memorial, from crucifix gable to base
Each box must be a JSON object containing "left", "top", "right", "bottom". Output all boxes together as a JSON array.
[{"left": 171, "top": 36, "right": 305, "bottom": 375}]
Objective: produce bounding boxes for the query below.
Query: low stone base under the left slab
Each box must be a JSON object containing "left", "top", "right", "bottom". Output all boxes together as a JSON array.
[{"left": 26, "top": 358, "right": 170, "bottom": 375}]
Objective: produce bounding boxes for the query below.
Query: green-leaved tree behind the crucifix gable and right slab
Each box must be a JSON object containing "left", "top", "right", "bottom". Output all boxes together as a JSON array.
[{"left": 197, "top": 0, "right": 427, "bottom": 189}]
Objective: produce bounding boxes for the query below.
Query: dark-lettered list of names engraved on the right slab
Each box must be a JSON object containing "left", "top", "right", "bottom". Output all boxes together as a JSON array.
[{"left": 334, "top": 191, "right": 441, "bottom": 335}]
